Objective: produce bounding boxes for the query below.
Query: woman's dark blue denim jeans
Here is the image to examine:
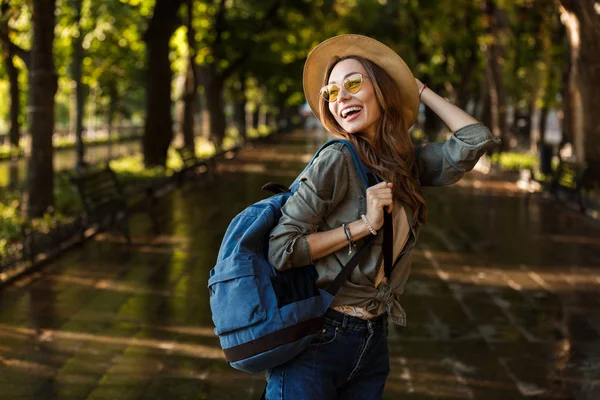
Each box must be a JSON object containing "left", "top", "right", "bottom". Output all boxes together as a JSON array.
[{"left": 266, "top": 309, "right": 390, "bottom": 400}]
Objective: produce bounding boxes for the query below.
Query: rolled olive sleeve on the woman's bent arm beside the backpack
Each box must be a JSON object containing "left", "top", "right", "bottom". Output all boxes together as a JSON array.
[{"left": 268, "top": 146, "right": 348, "bottom": 270}]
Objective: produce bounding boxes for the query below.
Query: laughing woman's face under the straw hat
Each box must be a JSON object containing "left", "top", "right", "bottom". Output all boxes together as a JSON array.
[{"left": 328, "top": 58, "right": 381, "bottom": 140}]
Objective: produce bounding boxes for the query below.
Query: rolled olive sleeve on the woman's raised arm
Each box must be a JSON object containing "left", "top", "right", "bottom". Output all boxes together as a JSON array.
[{"left": 416, "top": 123, "right": 500, "bottom": 186}]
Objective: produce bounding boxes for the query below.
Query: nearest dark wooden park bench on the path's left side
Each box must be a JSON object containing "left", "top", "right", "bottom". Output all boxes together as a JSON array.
[{"left": 70, "top": 165, "right": 158, "bottom": 244}]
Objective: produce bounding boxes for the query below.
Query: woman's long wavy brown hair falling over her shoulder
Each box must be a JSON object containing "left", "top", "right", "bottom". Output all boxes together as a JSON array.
[{"left": 319, "top": 56, "right": 427, "bottom": 223}]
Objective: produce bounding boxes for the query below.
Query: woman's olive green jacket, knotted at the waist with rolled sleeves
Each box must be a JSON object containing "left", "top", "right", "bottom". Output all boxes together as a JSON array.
[{"left": 269, "top": 123, "right": 500, "bottom": 325}]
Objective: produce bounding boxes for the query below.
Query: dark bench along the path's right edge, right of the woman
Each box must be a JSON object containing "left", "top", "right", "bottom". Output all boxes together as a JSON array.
[{"left": 527, "top": 160, "right": 590, "bottom": 214}]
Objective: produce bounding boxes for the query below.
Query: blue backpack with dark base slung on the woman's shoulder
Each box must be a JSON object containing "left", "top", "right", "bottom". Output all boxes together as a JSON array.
[{"left": 208, "top": 139, "right": 388, "bottom": 373}]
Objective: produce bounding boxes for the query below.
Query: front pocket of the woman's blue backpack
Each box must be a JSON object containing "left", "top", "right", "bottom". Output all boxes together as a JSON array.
[{"left": 208, "top": 254, "right": 266, "bottom": 335}]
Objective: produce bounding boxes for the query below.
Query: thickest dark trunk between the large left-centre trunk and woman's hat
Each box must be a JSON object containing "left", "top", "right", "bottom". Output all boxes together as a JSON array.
[{"left": 201, "top": 64, "right": 226, "bottom": 149}]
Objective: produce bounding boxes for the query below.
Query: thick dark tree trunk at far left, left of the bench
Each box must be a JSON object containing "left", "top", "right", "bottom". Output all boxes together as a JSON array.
[{"left": 26, "top": 0, "right": 58, "bottom": 217}]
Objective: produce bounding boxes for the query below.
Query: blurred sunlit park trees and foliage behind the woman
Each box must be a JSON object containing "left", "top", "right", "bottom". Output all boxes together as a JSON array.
[{"left": 0, "top": 0, "right": 600, "bottom": 244}]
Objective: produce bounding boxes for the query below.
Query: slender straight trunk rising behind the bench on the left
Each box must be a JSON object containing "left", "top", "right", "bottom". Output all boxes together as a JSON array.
[{"left": 71, "top": 0, "right": 85, "bottom": 169}]
